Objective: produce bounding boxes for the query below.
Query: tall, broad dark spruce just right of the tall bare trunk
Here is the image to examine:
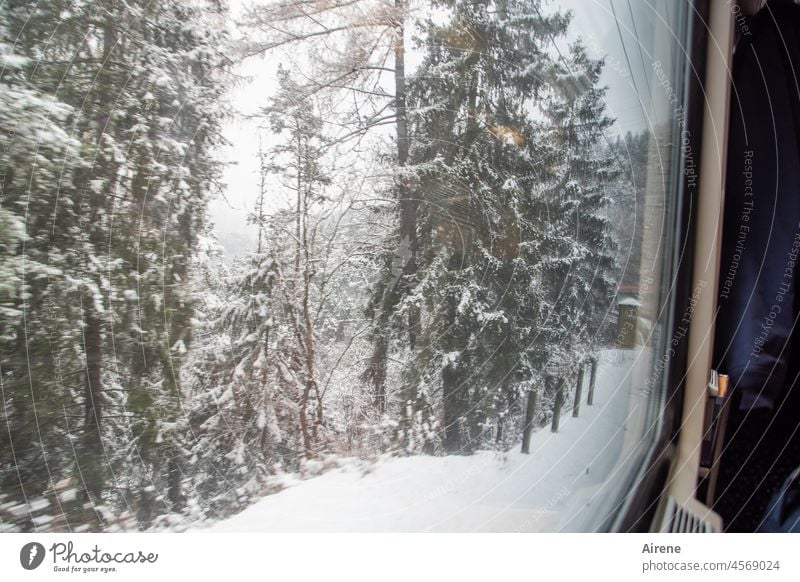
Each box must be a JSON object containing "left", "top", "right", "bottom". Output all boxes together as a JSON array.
[{"left": 401, "top": 1, "right": 568, "bottom": 452}]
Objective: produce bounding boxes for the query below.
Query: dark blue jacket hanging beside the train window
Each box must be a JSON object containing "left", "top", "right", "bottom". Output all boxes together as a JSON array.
[{"left": 716, "top": 0, "right": 800, "bottom": 408}]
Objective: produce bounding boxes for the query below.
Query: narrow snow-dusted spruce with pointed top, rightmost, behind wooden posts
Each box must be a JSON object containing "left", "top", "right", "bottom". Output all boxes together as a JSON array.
[{"left": 537, "top": 43, "right": 621, "bottom": 374}]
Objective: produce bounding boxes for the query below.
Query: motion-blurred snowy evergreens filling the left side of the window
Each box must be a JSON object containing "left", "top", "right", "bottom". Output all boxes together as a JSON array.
[{"left": 0, "top": 0, "right": 227, "bottom": 528}]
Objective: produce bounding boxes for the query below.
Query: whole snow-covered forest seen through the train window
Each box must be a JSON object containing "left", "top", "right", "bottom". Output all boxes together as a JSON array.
[{"left": 0, "top": 0, "right": 654, "bottom": 531}]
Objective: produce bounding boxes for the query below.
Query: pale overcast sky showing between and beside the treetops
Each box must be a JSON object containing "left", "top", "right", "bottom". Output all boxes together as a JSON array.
[{"left": 210, "top": 0, "right": 668, "bottom": 259}]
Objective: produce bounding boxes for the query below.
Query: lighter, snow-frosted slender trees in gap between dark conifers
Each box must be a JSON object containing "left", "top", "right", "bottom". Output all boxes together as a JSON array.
[{"left": 170, "top": 70, "right": 386, "bottom": 510}]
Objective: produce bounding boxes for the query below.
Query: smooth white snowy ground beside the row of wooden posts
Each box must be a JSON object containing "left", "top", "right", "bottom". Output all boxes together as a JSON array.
[{"left": 197, "top": 351, "right": 651, "bottom": 532}]
